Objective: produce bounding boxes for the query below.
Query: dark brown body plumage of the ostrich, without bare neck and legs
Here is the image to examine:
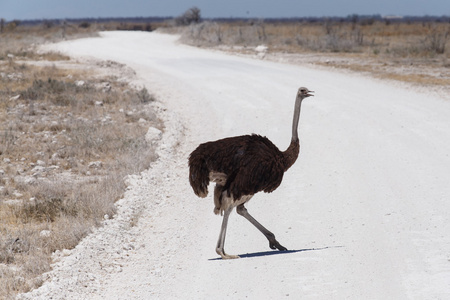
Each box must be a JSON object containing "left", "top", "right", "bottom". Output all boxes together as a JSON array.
[{"left": 189, "top": 134, "right": 300, "bottom": 200}]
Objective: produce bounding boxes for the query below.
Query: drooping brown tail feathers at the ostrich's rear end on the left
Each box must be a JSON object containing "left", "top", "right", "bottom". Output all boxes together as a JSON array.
[{"left": 189, "top": 155, "right": 209, "bottom": 198}]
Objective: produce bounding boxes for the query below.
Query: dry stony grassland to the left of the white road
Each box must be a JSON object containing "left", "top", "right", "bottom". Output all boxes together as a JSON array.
[{"left": 0, "top": 22, "right": 162, "bottom": 299}]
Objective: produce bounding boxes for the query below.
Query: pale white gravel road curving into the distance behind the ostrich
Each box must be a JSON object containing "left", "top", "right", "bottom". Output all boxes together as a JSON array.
[{"left": 19, "top": 32, "right": 450, "bottom": 299}]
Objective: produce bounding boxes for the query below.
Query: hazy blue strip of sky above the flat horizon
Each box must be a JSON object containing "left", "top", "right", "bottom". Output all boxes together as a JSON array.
[{"left": 0, "top": 0, "right": 450, "bottom": 21}]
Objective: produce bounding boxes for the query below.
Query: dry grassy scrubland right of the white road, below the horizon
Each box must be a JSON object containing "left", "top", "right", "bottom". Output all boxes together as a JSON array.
[{"left": 172, "top": 20, "right": 450, "bottom": 86}]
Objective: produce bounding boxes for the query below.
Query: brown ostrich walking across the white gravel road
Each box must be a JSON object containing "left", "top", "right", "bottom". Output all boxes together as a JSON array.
[{"left": 189, "top": 87, "right": 313, "bottom": 259}]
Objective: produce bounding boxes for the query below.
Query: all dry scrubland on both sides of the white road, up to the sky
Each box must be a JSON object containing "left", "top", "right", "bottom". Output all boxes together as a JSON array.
[{"left": 0, "top": 7, "right": 450, "bottom": 299}]
